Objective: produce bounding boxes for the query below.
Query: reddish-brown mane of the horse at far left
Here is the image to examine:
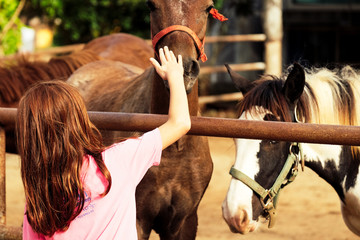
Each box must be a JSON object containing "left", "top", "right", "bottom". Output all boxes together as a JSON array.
[{"left": 0, "top": 50, "right": 100, "bottom": 106}]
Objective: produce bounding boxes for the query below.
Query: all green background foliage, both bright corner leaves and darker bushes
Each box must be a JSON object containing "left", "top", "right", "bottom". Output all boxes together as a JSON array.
[{"left": 0, "top": 0, "right": 225, "bottom": 52}]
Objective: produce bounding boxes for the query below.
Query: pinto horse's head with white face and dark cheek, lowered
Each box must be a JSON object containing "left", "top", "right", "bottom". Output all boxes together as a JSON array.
[{"left": 222, "top": 64, "right": 305, "bottom": 234}]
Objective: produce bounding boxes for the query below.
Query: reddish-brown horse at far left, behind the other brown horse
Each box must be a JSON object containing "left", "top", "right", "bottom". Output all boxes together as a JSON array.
[{"left": 0, "top": 33, "right": 153, "bottom": 153}]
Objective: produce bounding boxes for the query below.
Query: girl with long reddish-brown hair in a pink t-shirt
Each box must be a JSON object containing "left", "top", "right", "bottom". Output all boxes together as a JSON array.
[{"left": 16, "top": 47, "right": 191, "bottom": 240}]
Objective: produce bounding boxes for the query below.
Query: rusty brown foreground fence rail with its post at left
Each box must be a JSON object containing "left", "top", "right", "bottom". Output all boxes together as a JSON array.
[{"left": 0, "top": 108, "right": 360, "bottom": 239}]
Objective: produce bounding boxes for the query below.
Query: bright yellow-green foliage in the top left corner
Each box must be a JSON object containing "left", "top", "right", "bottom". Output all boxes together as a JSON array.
[{"left": 0, "top": 0, "right": 23, "bottom": 56}]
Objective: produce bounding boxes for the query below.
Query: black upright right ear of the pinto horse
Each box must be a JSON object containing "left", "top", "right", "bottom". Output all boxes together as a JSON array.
[{"left": 282, "top": 63, "right": 305, "bottom": 104}]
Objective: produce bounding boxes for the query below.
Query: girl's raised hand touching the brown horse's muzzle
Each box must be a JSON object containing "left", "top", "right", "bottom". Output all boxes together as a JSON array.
[{"left": 150, "top": 46, "right": 184, "bottom": 80}]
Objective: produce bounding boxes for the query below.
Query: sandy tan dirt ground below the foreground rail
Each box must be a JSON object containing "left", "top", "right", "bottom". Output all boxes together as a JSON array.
[{"left": 6, "top": 138, "right": 358, "bottom": 240}]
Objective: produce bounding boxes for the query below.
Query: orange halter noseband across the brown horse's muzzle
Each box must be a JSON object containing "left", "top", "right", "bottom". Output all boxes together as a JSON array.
[{"left": 152, "top": 25, "right": 207, "bottom": 62}]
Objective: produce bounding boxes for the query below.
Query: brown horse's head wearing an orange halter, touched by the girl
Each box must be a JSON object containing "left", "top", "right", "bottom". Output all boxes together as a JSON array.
[{"left": 147, "top": 0, "right": 213, "bottom": 92}]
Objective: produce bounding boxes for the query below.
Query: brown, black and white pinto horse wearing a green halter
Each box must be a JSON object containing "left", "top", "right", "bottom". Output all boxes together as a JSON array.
[{"left": 222, "top": 63, "right": 360, "bottom": 235}]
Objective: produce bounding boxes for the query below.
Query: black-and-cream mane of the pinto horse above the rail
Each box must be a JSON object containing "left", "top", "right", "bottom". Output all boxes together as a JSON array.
[{"left": 239, "top": 66, "right": 360, "bottom": 155}]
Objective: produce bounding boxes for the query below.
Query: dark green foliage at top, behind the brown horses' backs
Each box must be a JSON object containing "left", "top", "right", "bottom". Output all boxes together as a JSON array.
[{"left": 26, "top": 0, "right": 150, "bottom": 45}]
